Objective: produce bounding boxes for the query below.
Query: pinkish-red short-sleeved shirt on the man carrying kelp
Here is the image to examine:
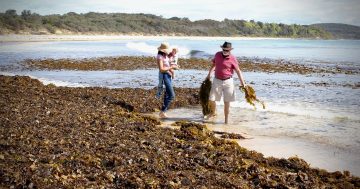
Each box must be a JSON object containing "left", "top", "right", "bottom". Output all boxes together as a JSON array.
[{"left": 212, "top": 51, "right": 239, "bottom": 79}]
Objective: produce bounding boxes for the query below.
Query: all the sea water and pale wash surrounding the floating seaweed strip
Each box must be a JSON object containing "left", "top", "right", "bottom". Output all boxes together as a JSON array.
[{"left": 0, "top": 38, "right": 360, "bottom": 176}]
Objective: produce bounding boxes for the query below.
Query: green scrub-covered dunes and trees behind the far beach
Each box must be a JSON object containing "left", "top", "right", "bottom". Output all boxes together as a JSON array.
[{"left": 0, "top": 10, "right": 332, "bottom": 39}]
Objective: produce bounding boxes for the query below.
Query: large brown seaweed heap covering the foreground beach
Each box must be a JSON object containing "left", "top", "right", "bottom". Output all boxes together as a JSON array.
[{"left": 0, "top": 76, "right": 360, "bottom": 188}]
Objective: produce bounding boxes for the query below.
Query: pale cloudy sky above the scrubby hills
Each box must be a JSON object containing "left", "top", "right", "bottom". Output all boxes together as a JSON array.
[{"left": 0, "top": 0, "right": 360, "bottom": 26}]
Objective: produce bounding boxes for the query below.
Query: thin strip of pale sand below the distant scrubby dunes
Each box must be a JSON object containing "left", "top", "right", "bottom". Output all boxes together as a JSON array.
[{"left": 0, "top": 34, "right": 310, "bottom": 42}]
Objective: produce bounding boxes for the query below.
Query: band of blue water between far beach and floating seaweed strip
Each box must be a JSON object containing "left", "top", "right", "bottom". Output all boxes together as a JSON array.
[{"left": 0, "top": 38, "right": 360, "bottom": 68}]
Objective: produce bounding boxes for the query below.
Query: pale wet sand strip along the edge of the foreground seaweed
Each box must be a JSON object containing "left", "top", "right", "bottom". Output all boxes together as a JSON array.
[{"left": 152, "top": 108, "right": 360, "bottom": 176}]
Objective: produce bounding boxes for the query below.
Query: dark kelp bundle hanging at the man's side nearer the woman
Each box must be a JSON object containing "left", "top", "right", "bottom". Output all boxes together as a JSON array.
[{"left": 199, "top": 78, "right": 215, "bottom": 117}]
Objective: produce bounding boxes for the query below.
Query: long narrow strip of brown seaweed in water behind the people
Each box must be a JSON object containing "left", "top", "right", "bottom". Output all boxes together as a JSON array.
[{"left": 23, "top": 56, "right": 360, "bottom": 74}]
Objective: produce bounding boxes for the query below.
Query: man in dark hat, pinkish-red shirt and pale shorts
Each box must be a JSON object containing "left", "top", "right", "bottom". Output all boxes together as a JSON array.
[{"left": 207, "top": 42, "right": 245, "bottom": 124}]
